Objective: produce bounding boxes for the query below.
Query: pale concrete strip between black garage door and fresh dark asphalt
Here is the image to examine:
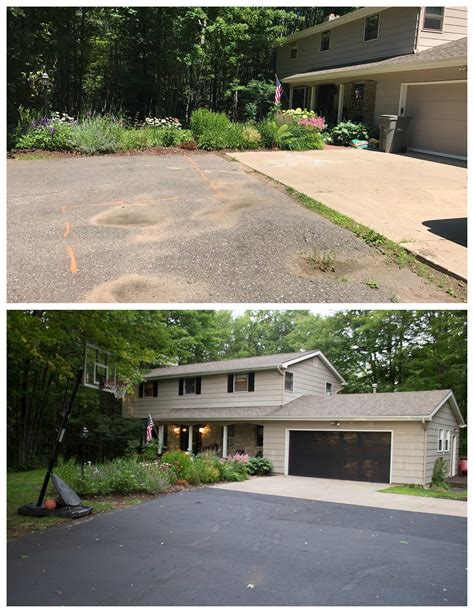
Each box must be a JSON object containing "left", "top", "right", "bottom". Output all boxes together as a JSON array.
[{"left": 213, "top": 475, "right": 467, "bottom": 517}]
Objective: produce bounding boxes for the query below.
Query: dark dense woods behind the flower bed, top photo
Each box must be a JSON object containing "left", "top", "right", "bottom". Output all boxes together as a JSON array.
[{"left": 7, "top": 6, "right": 354, "bottom": 124}]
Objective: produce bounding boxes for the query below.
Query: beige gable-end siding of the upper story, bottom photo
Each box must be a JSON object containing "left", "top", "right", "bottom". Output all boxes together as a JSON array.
[{"left": 284, "top": 358, "right": 342, "bottom": 404}]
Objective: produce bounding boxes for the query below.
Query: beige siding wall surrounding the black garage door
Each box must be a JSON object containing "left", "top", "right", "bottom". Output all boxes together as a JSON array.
[{"left": 263, "top": 421, "right": 424, "bottom": 485}]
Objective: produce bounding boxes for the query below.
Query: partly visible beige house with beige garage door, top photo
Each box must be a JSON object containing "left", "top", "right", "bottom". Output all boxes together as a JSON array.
[{"left": 276, "top": 6, "right": 467, "bottom": 159}]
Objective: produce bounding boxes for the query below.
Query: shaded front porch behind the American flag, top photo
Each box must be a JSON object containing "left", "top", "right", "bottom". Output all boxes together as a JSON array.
[{"left": 288, "top": 79, "right": 377, "bottom": 125}]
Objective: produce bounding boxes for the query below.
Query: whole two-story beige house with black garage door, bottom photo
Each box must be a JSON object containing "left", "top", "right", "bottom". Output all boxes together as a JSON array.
[{"left": 123, "top": 351, "right": 465, "bottom": 484}]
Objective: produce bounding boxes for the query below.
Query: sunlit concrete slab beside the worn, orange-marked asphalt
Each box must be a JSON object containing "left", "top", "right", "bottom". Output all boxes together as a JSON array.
[{"left": 228, "top": 148, "right": 467, "bottom": 280}]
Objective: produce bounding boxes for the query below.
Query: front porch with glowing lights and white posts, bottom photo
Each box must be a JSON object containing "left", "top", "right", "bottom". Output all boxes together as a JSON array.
[{"left": 155, "top": 421, "right": 263, "bottom": 458}]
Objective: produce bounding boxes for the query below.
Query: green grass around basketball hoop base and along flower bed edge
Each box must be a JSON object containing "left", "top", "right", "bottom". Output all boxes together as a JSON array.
[{"left": 7, "top": 468, "right": 147, "bottom": 539}]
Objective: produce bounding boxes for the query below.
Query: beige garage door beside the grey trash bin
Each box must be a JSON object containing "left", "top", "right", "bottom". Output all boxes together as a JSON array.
[{"left": 404, "top": 83, "right": 467, "bottom": 158}]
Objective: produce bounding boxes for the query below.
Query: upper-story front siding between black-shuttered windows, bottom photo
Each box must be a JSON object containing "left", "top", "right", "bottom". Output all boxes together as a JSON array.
[{"left": 123, "top": 369, "right": 283, "bottom": 418}]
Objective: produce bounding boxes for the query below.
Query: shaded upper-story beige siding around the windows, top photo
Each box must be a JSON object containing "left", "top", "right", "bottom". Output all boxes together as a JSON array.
[{"left": 277, "top": 7, "right": 419, "bottom": 78}]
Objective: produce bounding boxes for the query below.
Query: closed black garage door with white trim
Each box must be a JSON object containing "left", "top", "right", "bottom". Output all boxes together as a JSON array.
[{"left": 288, "top": 430, "right": 391, "bottom": 483}]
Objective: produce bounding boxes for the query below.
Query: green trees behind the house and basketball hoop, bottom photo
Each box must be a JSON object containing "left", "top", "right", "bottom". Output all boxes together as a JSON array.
[{"left": 8, "top": 310, "right": 467, "bottom": 467}]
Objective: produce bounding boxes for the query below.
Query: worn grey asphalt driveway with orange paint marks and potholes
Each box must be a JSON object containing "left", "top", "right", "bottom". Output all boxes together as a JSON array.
[{"left": 8, "top": 153, "right": 460, "bottom": 303}]
